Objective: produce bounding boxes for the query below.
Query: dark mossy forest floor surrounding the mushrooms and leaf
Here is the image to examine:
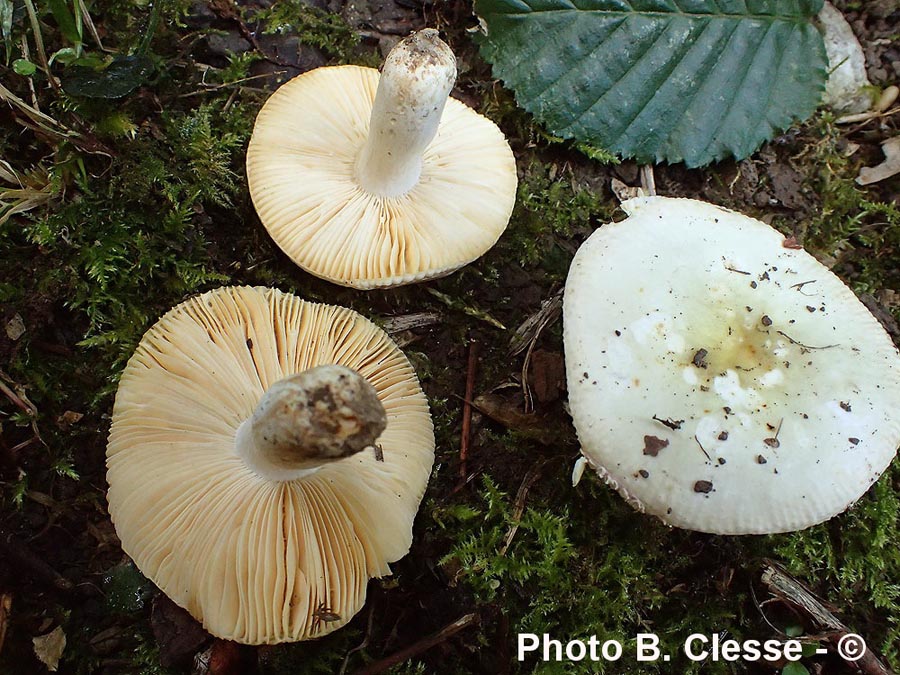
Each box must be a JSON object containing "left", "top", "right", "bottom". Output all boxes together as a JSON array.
[{"left": 0, "top": 0, "right": 900, "bottom": 675}]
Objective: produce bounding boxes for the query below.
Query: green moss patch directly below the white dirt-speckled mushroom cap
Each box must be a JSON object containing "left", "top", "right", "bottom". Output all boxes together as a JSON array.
[{"left": 442, "top": 460, "right": 900, "bottom": 673}]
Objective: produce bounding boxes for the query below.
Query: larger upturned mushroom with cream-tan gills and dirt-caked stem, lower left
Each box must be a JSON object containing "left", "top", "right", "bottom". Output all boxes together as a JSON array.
[{"left": 107, "top": 287, "right": 434, "bottom": 644}]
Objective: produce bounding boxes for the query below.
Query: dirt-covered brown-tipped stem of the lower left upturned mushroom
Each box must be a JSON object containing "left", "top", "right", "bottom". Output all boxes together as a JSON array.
[{"left": 235, "top": 365, "right": 387, "bottom": 481}]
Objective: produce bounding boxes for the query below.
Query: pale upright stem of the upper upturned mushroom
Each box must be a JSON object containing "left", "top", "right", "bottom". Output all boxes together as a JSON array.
[{"left": 356, "top": 28, "right": 456, "bottom": 197}]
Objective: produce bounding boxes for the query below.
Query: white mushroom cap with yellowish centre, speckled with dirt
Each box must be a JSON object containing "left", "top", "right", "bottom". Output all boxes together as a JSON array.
[{"left": 563, "top": 197, "right": 900, "bottom": 534}]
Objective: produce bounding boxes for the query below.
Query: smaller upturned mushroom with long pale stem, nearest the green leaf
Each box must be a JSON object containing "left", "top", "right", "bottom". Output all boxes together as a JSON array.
[{"left": 247, "top": 29, "right": 517, "bottom": 289}]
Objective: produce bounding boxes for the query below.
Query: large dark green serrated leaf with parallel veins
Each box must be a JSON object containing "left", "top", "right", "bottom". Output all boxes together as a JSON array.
[{"left": 476, "top": 0, "right": 827, "bottom": 167}]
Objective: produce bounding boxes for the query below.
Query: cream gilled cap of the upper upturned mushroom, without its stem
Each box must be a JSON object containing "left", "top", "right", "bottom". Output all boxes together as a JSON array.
[{"left": 247, "top": 66, "right": 518, "bottom": 289}]
